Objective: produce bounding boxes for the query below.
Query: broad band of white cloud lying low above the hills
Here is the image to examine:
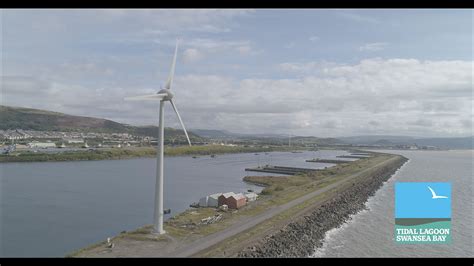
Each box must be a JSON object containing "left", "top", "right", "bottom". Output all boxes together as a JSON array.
[{"left": 2, "top": 58, "right": 472, "bottom": 137}]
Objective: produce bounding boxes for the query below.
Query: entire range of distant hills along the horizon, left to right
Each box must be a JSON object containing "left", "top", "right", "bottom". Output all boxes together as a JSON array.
[{"left": 0, "top": 105, "right": 474, "bottom": 149}]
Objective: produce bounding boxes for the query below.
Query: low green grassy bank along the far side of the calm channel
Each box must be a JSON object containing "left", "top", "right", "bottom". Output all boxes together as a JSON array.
[{"left": 0, "top": 145, "right": 308, "bottom": 162}]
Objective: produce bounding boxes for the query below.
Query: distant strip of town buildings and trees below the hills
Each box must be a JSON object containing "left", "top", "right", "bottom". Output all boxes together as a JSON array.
[{"left": 0, "top": 129, "right": 439, "bottom": 153}]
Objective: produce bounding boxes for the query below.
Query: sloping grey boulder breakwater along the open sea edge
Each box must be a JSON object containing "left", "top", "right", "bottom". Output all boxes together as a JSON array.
[{"left": 237, "top": 156, "right": 407, "bottom": 257}]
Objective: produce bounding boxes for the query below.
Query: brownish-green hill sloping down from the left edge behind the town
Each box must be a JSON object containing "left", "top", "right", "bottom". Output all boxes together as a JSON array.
[{"left": 0, "top": 105, "right": 202, "bottom": 140}]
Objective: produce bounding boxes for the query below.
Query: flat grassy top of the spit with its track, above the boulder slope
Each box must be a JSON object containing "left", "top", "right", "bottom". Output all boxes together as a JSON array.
[{"left": 68, "top": 153, "right": 406, "bottom": 257}]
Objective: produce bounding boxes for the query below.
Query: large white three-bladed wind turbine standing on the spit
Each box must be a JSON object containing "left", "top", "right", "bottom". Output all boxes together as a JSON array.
[{"left": 125, "top": 42, "right": 191, "bottom": 234}]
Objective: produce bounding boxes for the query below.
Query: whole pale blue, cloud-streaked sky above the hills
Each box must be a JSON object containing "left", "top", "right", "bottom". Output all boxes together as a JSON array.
[{"left": 0, "top": 9, "right": 474, "bottom": 137}]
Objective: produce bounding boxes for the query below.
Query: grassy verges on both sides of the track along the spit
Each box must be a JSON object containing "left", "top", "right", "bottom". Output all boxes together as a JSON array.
[{"left": 71, "top": 154, "right": 404, "bottom": 256}]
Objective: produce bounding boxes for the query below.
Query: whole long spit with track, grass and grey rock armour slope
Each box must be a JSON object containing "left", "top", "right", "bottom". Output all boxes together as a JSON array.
[{"left": 67, "top": 154, "right": 407, "bottom": 258}]
